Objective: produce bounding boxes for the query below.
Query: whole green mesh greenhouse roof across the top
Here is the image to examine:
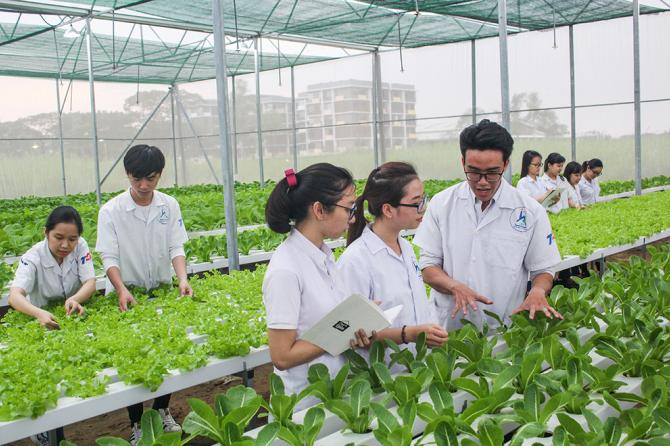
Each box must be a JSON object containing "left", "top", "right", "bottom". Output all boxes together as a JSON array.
[{"left": 0, "top": 0, "right": 667, "bottom": 83}]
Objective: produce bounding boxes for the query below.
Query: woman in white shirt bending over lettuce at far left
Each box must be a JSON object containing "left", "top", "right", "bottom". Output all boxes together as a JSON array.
[{"left": 8, "top": 206, "right": 95, "bottom": 446}]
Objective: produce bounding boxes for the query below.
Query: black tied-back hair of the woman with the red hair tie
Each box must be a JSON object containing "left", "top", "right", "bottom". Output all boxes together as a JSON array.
[{"left": 265, "top": 163, "right": 354, "bottom": 234}]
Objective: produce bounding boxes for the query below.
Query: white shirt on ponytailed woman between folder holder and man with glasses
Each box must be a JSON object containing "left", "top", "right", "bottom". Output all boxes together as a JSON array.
[{"left": 337, "top": 227, "right": 437, "bottom": 327}]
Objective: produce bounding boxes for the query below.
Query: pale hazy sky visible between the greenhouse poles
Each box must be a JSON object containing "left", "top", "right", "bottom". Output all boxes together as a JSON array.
[{"left": 0, "top": 7, "right": 670, "bottom": 136}]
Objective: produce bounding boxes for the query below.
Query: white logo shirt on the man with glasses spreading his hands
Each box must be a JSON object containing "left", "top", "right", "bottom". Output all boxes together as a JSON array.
[{"left": 414, "top": 179, "right": 561, "bottom": 330}]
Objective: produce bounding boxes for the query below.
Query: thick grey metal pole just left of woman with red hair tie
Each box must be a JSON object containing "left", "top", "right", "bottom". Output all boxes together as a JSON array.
[{"left": 212, "top": 0, "right": 240, "bottom": 271}]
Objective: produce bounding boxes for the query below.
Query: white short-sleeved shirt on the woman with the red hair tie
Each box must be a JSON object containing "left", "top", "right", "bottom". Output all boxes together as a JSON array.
[{"left": 263, "top": 229, "right": 346, "bottom": 398}]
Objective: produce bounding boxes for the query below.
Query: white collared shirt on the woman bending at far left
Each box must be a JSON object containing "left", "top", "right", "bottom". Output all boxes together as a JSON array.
[{"left": 10, "top": 237, "right": 95, "bottom": 308}]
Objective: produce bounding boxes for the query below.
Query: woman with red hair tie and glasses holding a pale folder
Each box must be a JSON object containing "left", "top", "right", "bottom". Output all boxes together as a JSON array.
[{"left": 263, "top": 163, "right": 370, "bottom": 410}]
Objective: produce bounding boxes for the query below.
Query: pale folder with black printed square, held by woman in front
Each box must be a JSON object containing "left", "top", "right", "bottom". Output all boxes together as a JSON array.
[{"left": 300, "top": 294, "right": 402, "bottom": 356}]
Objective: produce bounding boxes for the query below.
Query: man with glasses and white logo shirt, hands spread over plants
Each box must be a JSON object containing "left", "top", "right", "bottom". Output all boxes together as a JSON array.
[{"left": 414, "top": 119, "right": 562, "bottom": 330}]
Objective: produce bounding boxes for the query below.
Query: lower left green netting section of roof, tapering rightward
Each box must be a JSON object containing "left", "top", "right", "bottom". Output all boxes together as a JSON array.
[{"left": 0, "top": 23, "right": 338, "bottom": 84}]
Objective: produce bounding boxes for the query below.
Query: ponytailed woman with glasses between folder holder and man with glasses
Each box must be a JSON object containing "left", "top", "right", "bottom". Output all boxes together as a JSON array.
[{"left": 337, "top": 162, "right": 447, "bottom": 347}]
